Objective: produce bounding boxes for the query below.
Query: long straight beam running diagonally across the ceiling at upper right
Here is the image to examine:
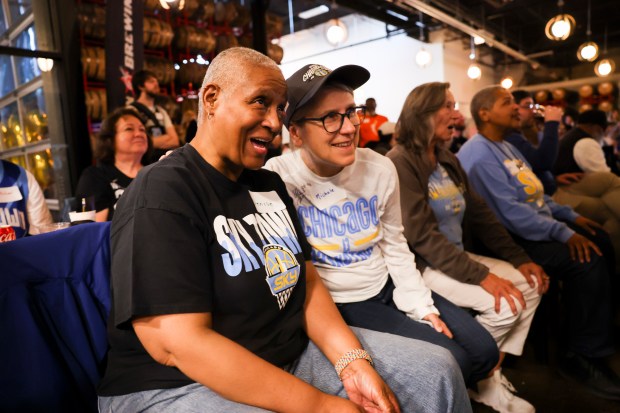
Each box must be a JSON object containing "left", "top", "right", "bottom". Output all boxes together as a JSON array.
[{"left": 388, "top": 0, "right": 540, "bottom": 69}]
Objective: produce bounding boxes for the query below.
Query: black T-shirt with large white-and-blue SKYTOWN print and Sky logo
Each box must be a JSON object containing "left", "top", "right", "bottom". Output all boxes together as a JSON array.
[{"left": 99, "top": 145, "right": 310, "bottom": 396}]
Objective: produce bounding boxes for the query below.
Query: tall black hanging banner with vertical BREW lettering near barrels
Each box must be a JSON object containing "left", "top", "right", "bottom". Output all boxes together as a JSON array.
[{"left": 105, "top": 0, "right": 144, "bottom": 112}]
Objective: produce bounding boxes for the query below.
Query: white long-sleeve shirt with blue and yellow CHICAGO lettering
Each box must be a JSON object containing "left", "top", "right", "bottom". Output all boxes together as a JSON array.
[{"left": 265, "top": 149, "right": 439, "bottom": 320}]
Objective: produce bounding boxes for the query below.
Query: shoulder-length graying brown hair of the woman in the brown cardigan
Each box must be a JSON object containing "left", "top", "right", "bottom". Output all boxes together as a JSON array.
[{"left": 396, "top": 82, "right": 450, "bottom": 151}]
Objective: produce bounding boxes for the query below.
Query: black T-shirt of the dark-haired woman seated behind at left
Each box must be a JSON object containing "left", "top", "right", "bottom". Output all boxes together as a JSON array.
[{"left": 75, "top": 163, "right": 133, "bottom": 221}]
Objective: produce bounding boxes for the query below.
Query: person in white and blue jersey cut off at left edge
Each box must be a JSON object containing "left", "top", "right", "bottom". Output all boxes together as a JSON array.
[{"left": 0, "top": 159, "right": 54, "bottom": 238}]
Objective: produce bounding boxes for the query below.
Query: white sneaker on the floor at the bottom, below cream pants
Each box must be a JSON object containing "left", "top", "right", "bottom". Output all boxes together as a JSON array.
[{"left": 468, "top": 369, "right": 536, "bottom": 413}]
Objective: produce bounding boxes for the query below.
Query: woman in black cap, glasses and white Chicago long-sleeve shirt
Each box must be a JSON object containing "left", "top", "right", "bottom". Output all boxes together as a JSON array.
[{"left": 266, "top": 65, "right": 498, "bottom": 390}]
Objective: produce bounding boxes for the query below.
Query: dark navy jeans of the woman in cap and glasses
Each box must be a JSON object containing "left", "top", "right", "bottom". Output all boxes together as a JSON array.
[{"left": 338, "top": 279, "right": 499, "bottom": 386}]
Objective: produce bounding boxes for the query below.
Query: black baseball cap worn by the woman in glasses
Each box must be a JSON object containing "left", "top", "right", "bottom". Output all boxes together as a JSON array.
[{"left": 284, "top": 64, "right": 370, "bottom": 128}]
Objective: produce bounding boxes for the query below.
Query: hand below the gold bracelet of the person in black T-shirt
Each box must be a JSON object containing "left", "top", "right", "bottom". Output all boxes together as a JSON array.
[{"left": 341, "top": 359, "right": 400, "bottom": 413}]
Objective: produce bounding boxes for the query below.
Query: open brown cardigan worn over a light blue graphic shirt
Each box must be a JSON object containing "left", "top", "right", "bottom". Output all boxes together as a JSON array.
[{"left": 387, "top": 145, "right": 531, "bottom": 285}]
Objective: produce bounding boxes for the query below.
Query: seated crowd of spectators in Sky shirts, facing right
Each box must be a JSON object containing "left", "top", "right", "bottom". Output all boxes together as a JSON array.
[{"left": 0, "top": 47, "right": 620, "bottom": 413}]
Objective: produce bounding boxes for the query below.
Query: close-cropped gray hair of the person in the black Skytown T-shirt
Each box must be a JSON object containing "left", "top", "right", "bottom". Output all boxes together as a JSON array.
[{"left": 197, "top": 47, "right": 280, "bottom": 125}]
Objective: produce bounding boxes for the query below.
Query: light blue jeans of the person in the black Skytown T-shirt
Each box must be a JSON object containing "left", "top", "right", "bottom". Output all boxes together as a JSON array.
[{"left": 99, "top": 328, "right": 472, "bottom": 413}]
